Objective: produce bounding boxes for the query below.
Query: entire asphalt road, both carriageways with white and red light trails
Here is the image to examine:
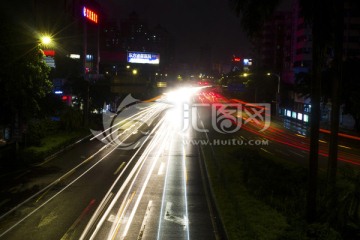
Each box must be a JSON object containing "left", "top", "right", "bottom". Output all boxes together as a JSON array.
[{"left": 0, "top": 86, "right": 360, "bottom": 240}]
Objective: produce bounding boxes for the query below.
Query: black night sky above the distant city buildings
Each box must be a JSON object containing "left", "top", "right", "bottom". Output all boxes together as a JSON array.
[{"left": 98, "top": 0, "right": 250, "bottom": 63}]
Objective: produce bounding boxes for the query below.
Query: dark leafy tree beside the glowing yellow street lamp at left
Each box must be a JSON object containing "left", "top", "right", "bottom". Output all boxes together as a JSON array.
[{"left": 0, "top": 16, "right": 52, "bottom": 128}]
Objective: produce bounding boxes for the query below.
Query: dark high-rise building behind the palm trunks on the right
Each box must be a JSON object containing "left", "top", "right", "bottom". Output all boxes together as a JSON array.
[{"left": 282, "top": 0, "right": 360, "bottom": 120}]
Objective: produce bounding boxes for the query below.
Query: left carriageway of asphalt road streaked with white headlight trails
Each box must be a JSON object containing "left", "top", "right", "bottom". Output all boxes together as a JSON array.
[{"left": 0, "top": 92, "right": 222, "bottom": 240}]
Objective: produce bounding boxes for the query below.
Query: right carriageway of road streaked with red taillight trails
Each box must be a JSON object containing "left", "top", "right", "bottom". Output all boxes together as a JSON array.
[{"left": 199, "top": 89, "right": 360, "bottom": 170}]
